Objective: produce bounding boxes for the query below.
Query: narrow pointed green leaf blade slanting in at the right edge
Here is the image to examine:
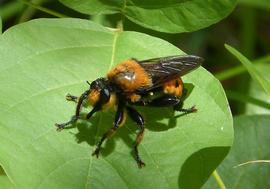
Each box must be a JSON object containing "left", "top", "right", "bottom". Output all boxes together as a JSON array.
[{"left": 225, "top": 44, "right": 270, "bottom": 95}]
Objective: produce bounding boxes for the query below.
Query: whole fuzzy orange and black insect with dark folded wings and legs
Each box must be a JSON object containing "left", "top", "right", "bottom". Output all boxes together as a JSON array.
[{"left": 56, "top": 55, "right": 203, "bottom": 167}]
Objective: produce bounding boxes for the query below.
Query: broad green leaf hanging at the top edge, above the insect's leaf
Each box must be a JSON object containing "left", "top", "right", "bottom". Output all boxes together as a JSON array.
[{"left": 59, "top": 0, "right": 236, "bottom": 33}]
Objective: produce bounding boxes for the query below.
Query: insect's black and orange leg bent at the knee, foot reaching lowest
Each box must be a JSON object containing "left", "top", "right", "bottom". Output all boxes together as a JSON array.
[{"left": 127, "top": 107, "right": 145, "bottom": 168}]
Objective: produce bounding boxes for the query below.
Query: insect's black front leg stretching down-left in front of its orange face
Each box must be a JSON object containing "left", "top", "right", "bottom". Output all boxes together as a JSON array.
[{"left": 55, "top": 90, "right": 89, "bottom": 131}]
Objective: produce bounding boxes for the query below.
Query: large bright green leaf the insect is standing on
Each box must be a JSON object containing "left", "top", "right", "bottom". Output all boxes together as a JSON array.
[{"left": 0, "top": 19, "right": 233, "bottom": 189}]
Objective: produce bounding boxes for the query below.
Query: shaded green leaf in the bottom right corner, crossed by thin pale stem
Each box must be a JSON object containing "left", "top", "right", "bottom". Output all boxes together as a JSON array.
[{"left": 203, "top": 115, "right": 270, "bottom": 189}]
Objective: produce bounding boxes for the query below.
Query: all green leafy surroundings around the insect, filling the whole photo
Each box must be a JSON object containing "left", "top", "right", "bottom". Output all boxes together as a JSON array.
[{"left": 0, "top": 0, "right": 270, "bottom": 189}]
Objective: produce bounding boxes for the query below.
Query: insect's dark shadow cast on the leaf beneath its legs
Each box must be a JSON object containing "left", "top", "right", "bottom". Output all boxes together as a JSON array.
[{"left": 63, "top": 84, "right": 194, "bottom": 159}]
